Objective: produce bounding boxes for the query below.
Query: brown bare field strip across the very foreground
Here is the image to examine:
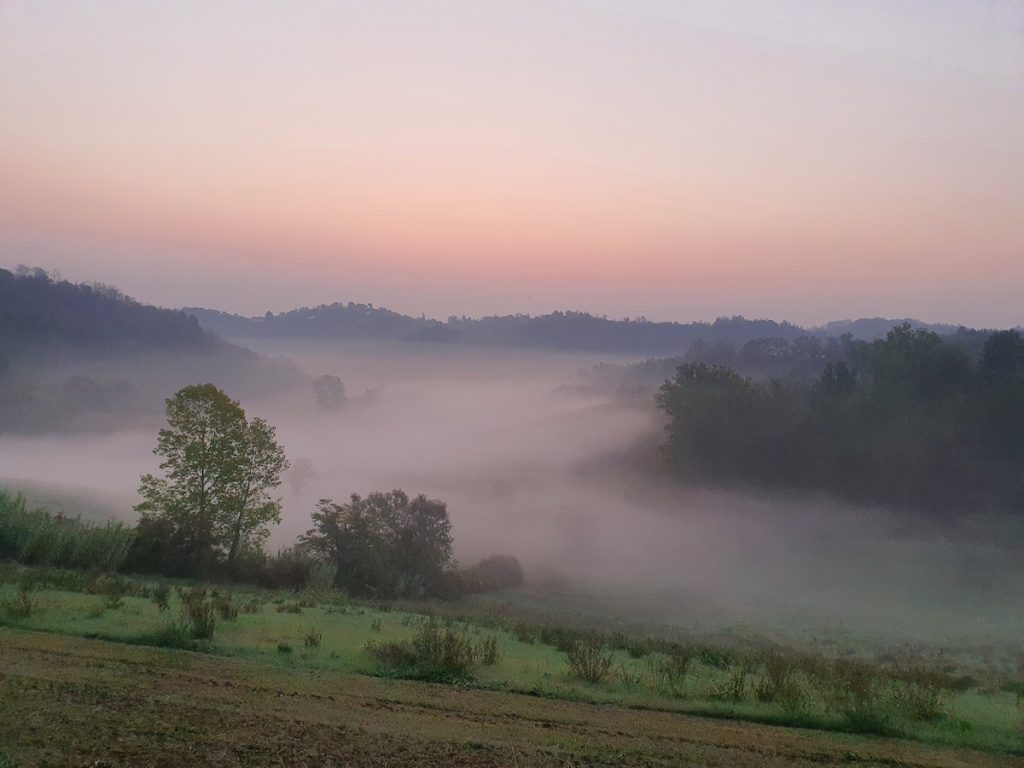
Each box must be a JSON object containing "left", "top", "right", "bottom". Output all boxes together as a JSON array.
[{"left": 0, "top": 629, "right": 1020, "bottom": 768}]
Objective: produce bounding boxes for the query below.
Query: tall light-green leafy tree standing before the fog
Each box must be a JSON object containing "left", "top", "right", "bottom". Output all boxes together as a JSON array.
[{"left": 135, "top": 384, "right": 288, "bottom": 572}]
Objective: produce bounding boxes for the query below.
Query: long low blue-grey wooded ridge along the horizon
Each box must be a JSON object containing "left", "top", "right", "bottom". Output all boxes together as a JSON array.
[{"left": 182, "top": 302, "right": 956, "bottom": 354}]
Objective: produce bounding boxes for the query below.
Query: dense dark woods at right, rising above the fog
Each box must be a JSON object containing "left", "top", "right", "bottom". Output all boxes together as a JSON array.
[{"left": 656, "top": 325, "right": 1024, "bottom": 514}]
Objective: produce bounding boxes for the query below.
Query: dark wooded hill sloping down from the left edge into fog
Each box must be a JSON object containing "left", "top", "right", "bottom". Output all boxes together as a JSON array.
[{"left": 0, "top": 267, "right": 302, "bottom": 433}]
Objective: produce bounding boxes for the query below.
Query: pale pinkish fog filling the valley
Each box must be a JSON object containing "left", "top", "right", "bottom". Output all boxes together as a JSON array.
[{"left": 0, "top": 342, "right": 1024, "bottom": 643}]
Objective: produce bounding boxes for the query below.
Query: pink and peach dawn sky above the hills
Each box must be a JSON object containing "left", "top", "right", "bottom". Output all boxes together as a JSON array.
[{"left": 0, "top": 0, "right": 1024, "bottom": 327}]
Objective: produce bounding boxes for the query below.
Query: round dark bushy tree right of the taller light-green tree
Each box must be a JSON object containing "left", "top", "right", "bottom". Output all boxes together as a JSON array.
[{"left": 302, "top": 490, "right": 453, "bottom": 597}]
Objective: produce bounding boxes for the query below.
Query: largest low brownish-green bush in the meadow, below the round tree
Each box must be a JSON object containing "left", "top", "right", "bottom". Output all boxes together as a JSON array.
[{"left": 366, "top": 620, "right": 476, "bottom": 683}]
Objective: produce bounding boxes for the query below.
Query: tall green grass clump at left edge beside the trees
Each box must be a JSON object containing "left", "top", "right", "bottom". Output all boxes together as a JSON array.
[{"left": 0, "top": 489, "right": 132, "bottom": 572}]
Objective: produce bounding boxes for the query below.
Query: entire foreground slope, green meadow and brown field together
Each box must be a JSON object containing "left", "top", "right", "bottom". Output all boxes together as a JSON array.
[{"left": 0, "top": 566, "right": 1024, "bottom": 768}]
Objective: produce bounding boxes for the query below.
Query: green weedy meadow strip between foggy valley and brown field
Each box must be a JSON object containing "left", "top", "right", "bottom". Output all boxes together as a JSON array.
[{"left": 0, "top": 566, "right": 1024, "bottom": 755}]
